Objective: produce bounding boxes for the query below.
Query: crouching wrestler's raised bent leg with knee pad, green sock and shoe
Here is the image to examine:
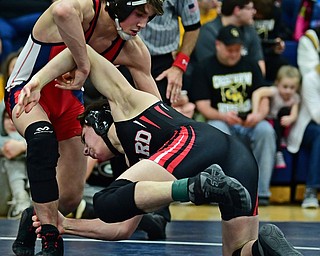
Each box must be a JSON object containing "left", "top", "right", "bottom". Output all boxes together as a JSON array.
[{"left": 93, "top": 160, "right": 251, "bottom": 223}]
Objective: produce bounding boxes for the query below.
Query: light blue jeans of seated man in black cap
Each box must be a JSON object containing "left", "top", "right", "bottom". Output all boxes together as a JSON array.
[{"left": 208, "top": 120, "right": 276, "bottom": 197}]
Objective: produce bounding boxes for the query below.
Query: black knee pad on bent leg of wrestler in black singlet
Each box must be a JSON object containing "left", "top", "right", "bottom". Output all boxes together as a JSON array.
[{"left": 93, "top": 179, "right": 145, "bottom": 223}]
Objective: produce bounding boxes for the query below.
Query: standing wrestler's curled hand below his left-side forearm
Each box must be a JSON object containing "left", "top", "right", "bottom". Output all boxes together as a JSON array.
[{"left": 55, "top": 69, "right": 88, "bottom": 90}]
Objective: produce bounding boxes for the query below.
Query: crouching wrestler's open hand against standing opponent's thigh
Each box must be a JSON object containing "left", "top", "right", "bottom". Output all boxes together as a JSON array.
[{"left": 16, "top": 78, "right": 41, "bottom": 118}]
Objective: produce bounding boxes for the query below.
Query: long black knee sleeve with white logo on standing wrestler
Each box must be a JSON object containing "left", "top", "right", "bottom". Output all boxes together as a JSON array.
[{"left": 25, "top": 121, "right": 59, "bottom": 203}]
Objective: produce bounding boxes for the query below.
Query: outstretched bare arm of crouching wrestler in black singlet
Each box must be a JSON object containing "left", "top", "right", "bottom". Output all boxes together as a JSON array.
[{"left": 15, "top": 46, "right": 159, "bottom": 121}]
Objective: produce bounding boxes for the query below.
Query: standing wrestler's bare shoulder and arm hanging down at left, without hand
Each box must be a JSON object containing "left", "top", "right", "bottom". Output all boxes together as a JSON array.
[{"left": 33, "top": 0, "right": 94, "bottom": 89}]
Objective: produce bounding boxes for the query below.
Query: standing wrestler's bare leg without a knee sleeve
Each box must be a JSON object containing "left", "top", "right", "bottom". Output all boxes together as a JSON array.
[{"left": 57, "top": 136, "right": 87, "bottom": 214}]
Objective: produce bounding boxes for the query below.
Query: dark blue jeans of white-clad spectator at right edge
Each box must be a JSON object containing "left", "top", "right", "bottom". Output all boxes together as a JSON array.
[{"left": 300, "top": 121, "right": 320, "bottom": 188}]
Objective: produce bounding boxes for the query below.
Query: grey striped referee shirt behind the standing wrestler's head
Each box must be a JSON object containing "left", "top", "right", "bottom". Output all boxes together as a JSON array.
[{"left": 139, "top": 0, "right": 201, "bottom": 55}]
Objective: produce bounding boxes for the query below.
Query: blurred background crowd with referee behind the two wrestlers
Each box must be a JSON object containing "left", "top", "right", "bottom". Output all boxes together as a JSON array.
[{"left": 0, "top": 0, "right": 320, "bottom": 224}]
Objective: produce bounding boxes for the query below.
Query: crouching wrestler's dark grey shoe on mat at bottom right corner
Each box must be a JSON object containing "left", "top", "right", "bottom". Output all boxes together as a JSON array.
[{"left": 258, "top": 224, "right": 302, "bottom": 256}]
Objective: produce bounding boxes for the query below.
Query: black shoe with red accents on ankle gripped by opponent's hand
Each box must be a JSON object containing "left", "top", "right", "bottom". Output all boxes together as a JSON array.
[{"left": 36, "top": 224, "right": 63, "bottom": 256}]
